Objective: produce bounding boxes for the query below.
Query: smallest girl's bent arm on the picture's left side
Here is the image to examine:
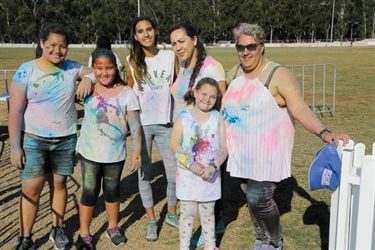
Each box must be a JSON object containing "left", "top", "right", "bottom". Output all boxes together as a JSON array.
[{"left": 170, "top": 117, "right": 204, "bottom": 175}]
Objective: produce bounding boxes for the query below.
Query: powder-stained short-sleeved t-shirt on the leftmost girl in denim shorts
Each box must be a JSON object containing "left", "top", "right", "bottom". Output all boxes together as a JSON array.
[{"left": 13, "top": 59, "right": 82, "bottom": 138}]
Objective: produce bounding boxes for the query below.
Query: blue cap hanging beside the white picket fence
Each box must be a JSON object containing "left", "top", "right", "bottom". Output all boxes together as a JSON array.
[{"left": 309, "top": 142, "right": 341, "bottom": 191}]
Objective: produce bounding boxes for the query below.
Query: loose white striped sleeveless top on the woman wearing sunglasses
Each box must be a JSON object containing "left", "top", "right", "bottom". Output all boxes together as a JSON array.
[{"left": 222, "top": 64, "right": 295, "bottom": 182}]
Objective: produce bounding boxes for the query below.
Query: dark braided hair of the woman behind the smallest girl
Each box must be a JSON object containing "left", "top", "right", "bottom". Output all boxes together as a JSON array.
[{"left": 169, "top": 21, "right": 207, "bottom": 104}]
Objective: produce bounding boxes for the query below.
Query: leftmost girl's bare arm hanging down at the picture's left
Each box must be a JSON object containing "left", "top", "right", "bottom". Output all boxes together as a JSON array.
[{"left": 8, "top": 81, "right": 27, "bottom": 169}]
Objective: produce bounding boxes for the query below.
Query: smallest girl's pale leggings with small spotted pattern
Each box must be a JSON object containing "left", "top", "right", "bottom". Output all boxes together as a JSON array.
[{"left": 179, "top": 201, "right": 216, "bottom": 250}]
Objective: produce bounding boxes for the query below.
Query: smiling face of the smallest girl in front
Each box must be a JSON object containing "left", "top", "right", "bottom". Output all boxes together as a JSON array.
[{"left": 194, "top": 84, "right": 217, "bottom": 112}]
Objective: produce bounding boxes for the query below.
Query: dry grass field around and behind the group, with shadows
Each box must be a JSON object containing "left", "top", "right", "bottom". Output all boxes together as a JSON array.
[{"left": 0, "top": 47, "right": 375, "bottom": 250}]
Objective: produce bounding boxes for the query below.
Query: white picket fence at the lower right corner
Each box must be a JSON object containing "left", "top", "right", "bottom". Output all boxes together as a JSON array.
[{"left": 329, "top": 141, "right": 375, "bottom": 250}]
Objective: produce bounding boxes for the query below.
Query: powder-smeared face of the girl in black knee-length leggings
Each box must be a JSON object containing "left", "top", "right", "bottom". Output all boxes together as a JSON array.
[{"left": 92, "top": 57, "right": 117, "bottom": 86}]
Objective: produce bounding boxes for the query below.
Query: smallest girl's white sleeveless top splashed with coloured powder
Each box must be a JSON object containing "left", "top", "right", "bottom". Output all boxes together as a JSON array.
[{"left": 176, "top": 110, "right": 221, "bottom": 202}]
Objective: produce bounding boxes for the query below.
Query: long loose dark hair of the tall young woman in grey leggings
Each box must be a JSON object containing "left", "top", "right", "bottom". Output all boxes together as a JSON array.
[{"left": 129, "top": 16, "right": 158, "bottom": 89}]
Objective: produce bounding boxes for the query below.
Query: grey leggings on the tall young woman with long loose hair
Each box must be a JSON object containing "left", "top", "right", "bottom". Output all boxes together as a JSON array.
[{"left": 138, "top": 124, "right": 177, "bottom": 208}]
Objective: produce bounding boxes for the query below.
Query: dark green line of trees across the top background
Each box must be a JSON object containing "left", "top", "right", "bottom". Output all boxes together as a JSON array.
[{"left": 0, "top": 0, "right": 375, "bottom": 44}]
